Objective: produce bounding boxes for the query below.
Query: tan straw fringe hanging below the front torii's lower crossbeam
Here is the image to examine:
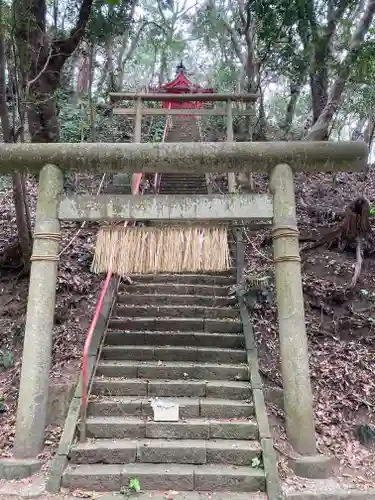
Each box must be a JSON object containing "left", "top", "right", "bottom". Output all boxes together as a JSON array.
[{"left": 91, "top": 226, "right": 230, "bottom": 276}]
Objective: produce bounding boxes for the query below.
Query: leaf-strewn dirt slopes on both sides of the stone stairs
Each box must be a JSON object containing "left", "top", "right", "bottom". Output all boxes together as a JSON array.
[{"left": 0, "top": 171, "right": 375, "bottom": 490}]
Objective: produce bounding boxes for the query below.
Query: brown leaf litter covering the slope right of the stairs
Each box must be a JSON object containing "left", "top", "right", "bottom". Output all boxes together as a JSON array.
[{"left": 246, "top": 170, "right": 375, "bottom": 489}]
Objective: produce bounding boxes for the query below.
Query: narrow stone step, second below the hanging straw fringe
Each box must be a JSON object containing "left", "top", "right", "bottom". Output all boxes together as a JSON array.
[{"left": 120, "top": 282, "right": 229, "bottom": 297}]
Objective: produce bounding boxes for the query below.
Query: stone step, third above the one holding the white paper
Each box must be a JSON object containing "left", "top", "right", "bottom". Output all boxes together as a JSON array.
[{"left": 102, "top": 344, "right": 247, "bottom": 363}]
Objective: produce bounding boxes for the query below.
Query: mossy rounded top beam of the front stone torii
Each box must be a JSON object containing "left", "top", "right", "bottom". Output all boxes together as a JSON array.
[{"left": 0, "top": 141, "right": 368, "bottom": 173}]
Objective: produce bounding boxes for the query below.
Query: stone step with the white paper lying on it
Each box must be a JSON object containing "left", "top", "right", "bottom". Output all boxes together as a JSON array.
[{"left": 87, "top": 396, "right": 254, "bottom": 420}]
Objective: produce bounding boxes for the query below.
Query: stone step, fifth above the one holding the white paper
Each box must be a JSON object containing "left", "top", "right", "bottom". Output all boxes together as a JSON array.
[{"left": 109, "top": 317, "right": 242, "bottom": 333}]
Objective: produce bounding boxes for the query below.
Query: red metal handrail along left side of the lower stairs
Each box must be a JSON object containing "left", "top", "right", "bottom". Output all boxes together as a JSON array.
[{"left": 80, "top": 173, "right": 143, "bottom": 441}]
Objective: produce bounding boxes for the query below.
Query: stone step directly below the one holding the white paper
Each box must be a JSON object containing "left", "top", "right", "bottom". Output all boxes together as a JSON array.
[{"left": 86, "top": 416, "right": 258, "bottom": 440}]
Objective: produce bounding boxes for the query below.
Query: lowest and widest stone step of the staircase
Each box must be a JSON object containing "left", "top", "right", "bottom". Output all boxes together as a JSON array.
[{"left": 62, "top": 463, "right": 265, "bottom": 492}]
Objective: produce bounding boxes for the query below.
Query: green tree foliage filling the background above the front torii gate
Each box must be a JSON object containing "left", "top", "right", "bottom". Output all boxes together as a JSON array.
[{"left": 18, "top": 0, "right": 375, "bottom": 142}]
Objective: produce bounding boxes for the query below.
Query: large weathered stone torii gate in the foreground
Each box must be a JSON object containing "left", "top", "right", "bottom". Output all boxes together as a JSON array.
[{"left": 0, "top": 141, "right": 368, "bottom": 472}]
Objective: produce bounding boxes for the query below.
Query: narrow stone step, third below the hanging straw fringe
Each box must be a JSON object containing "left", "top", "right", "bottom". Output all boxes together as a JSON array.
[{"left": 117, "top": 292, "right": 236, "bottom": 307}]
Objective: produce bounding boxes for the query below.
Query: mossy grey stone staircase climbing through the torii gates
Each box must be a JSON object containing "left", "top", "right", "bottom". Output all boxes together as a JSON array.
[{"left": 62, "top": 117, "right": 276, "bottom": 494}]
